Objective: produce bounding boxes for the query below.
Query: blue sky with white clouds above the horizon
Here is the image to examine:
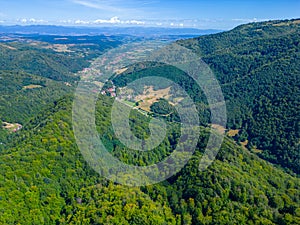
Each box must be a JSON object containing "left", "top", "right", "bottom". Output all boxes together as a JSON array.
[{"left": 0, "top": 0, "right": 300, "bottom": 29}]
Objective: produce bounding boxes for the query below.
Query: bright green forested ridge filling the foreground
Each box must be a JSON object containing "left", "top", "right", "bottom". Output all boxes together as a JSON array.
[{"left": 0, "top": 96, "right": 300, "bottom": 224}]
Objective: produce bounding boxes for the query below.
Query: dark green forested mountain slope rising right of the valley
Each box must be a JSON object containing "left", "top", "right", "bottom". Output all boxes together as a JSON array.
[{"left": 113, "top": 20, "right": 300, "bottom": 173}]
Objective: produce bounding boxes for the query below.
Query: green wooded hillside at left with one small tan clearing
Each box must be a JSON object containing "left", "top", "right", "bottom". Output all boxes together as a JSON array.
[{"left": 0, "top": 71, "right": 73, "bottom": 123}]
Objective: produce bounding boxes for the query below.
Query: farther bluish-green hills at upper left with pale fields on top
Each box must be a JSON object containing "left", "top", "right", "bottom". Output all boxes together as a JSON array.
[{"left": 0, "top": 35, "right": 122, "bottom": 82}]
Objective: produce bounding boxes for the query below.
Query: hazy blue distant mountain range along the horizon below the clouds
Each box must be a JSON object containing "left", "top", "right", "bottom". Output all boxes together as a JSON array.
[{"left": 0, "top": 25, "right": 220, "bottom": 36}]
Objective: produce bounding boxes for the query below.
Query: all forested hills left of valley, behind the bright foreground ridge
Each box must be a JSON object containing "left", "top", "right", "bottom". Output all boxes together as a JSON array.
[{"left": 0, "top": 34, "right": 124, "bottom": 144}]
